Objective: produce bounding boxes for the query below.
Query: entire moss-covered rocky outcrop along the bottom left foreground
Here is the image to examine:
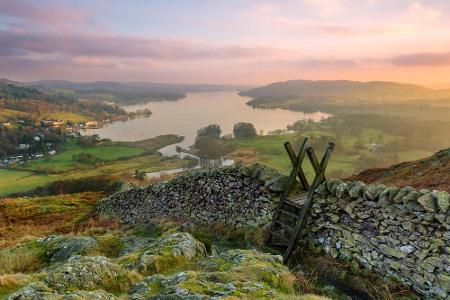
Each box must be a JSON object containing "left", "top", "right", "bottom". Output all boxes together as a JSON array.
[{"left": 8, "top": 230, "right": 294, "bottom": 300}]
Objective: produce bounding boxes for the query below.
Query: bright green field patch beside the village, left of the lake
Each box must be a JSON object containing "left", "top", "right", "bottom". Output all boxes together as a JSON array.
[{"left": 21, "top": 142, "right": 144, "bottom": 173}]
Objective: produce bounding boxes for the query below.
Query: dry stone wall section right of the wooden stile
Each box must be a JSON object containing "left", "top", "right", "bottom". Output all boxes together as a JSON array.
[{"left": 303, "top": 180, "right": 450, "bottom": 299}]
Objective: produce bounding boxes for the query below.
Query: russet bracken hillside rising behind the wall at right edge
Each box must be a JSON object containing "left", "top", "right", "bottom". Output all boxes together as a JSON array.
[{"left": 349, "top": 148, "right": 450, "bottom": 192}]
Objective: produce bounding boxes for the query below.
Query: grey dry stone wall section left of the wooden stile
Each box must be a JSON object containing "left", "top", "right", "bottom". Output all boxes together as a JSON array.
[{"left": 96, "top": 164, "right": 286, "bottom": 226}]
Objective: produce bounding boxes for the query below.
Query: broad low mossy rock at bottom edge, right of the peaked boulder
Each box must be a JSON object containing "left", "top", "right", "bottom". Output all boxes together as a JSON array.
[{"left": 129, "top": 250, "right": 294, "bottom": 300}]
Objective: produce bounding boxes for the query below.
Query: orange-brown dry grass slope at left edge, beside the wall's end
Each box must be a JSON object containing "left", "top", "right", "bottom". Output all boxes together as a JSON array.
[{"left": 0, "top": 192, "right": 103, "bottom": 249}]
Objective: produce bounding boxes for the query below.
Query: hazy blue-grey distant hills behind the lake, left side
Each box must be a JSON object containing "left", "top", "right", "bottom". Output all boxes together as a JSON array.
[{"left": 26, "top": 80, "right": 248, "bottom": 104}]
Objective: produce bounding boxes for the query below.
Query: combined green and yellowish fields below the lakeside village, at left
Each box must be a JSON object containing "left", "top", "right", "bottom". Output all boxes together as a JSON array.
[{"left": 0, "top": 135, "right": 191, "bottom": 196}]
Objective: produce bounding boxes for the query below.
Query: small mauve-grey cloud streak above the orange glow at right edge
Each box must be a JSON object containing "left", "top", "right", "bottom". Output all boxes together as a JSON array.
[{"left": 390, "top": 52, "right": 450, "bottom": 66}]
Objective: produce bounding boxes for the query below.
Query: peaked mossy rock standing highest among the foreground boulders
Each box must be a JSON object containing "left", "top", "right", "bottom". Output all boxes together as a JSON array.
[{"left": 135, "top": 232, "right": 207, "bottom": 274}]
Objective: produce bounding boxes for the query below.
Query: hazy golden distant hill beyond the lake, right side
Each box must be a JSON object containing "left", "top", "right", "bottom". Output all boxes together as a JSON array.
[{"left": 241, "top": 80, "right": 450, "bottom": 104}]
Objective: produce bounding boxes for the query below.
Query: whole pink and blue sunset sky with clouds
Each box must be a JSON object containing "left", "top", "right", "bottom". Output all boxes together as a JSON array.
[{"left": 0, "top": 0, "right": 450, "bottom": 85}]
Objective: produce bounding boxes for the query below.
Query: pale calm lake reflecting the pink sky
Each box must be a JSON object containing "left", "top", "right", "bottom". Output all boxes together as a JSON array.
[{"left": 87, "top": 91, "right": 329, "bottom": 155}]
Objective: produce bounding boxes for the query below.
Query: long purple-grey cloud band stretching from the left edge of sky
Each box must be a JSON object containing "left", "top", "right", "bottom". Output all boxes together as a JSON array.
[{"left": 0, "top": 30, "right": 286, "bottom": 60}]
